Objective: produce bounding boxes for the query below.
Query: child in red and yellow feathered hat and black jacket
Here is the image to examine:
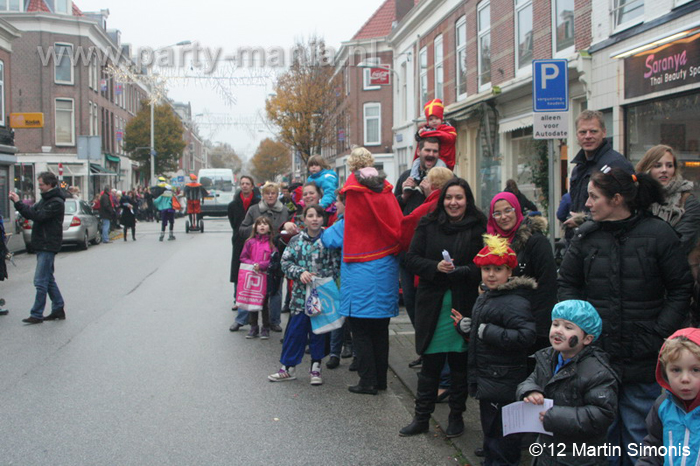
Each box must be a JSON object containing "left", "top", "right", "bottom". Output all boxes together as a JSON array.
[{"left": 452, "top": 234, "right": 537, "bottom": 465}]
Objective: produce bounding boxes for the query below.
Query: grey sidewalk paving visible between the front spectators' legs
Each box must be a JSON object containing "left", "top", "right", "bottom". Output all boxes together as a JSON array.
[{"left": 389, "top": 307, "right": 483, "bottom": 465}]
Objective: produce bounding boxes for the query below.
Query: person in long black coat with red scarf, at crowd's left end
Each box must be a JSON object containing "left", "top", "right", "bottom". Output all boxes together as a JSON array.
[{"left": 228, "top": 175, "right": 260, "bottom": 332}]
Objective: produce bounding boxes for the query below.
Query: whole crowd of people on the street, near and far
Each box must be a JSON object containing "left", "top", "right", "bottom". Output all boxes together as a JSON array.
[{"left": 5, "top": 99, "right": 700, "bottom": 465}]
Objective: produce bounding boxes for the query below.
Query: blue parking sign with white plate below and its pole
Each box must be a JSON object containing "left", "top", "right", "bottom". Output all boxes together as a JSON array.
[{"left": 532, "top": 59, "right": 569, "bottom": 248}]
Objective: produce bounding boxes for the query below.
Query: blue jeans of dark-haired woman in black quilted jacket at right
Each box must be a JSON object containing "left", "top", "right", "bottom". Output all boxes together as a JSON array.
[{"left": 608, "top": 383, "right": 661, "bottom": 466}]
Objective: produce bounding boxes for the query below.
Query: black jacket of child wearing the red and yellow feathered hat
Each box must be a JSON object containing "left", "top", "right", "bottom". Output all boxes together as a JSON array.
[{"left": 464, "top": 277, "right": 537, "bottom": 403}]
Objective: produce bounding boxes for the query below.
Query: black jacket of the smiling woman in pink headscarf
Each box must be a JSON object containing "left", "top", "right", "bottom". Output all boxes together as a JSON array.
[{"left": 510, "top": 216, "right": 557, "bottom": 337}]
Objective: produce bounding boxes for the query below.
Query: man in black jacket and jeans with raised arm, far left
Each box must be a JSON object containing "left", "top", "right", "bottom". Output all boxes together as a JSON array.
[{"left": 10, "top": 172, "right": 66, "bottom": 324}]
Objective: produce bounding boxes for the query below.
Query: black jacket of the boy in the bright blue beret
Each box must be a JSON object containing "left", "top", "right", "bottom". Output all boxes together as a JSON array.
[{"left": 516, "top": 346, "right": 618, "bottom": 465}]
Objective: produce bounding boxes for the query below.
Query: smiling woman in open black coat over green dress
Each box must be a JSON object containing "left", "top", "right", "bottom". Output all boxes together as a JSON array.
[{"left": 400, "top": 178, "right": 486, "bottom": 437}]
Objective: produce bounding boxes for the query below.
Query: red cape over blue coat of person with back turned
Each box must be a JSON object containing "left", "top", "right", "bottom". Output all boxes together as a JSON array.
[{"left": 341, "top": 173, "right": 403, "bottom": 262}]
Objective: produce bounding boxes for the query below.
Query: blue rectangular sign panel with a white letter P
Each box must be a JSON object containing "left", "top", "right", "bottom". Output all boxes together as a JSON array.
[{"left": 532, "top": 59, "right": 569, "bottom": 112}]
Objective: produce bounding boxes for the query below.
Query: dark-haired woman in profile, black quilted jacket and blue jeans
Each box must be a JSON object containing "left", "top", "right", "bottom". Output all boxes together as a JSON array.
[{"left": 559, "top": 167, "right": 692, "bottom": 464}]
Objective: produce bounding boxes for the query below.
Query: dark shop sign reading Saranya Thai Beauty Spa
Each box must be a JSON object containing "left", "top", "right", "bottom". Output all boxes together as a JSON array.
[{"left": 625, "top": 33, "right": 700, "bottom": 99}]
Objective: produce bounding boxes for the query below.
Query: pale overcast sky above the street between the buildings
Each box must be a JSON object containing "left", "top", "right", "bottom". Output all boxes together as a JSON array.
[{"left": 74, "top": 0, "right": 383, "bottom": 157}]
